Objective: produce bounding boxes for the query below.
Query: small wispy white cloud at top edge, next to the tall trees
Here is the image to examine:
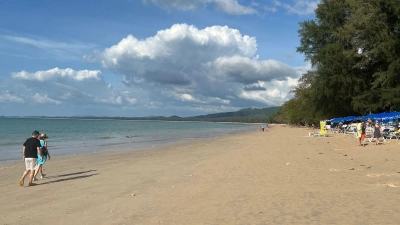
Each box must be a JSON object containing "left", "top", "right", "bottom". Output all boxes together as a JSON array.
[{"left": 273, "top": 0, "right": 321, "bottom": 15}]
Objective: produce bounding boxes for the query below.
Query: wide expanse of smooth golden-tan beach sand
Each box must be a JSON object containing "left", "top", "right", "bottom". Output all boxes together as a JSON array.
[{"left": 0, "top": 125, "right": 400, "bottom": 225}]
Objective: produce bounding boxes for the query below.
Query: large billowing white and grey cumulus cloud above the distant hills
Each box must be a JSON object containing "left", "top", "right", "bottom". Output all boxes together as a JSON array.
[{"left": 90, "top": 24, "right": 299, "bottom": 108}]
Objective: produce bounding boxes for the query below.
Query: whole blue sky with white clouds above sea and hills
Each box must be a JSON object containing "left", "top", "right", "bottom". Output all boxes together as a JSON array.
[{"left": 0, "top": 0, "right": 319, "bottom": 116}]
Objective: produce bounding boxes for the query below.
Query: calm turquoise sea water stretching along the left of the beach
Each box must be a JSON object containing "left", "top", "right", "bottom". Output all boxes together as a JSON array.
[{"left": 0, "top": 118, "right": 254, "bottom": 163}]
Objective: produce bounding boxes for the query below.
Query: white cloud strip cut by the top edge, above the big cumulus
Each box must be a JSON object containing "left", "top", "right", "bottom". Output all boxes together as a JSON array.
[{"left": 143, "top": 0, "right": 258, "bottom": 15}]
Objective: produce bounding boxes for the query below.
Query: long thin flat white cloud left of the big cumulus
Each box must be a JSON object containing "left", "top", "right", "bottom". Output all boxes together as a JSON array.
[{"left": 11, "top": 67, "right": 101, "bottom": 82}]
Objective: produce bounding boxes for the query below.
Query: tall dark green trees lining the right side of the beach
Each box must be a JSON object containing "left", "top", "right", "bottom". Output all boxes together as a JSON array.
[{"left": 270, "top": 0, "right": 400, "bottom": 125}]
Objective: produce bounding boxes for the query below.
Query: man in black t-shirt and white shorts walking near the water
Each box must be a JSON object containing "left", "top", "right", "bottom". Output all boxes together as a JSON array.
[{"left": 19, "top": 130, "right": 43, "bottom": 187}]
